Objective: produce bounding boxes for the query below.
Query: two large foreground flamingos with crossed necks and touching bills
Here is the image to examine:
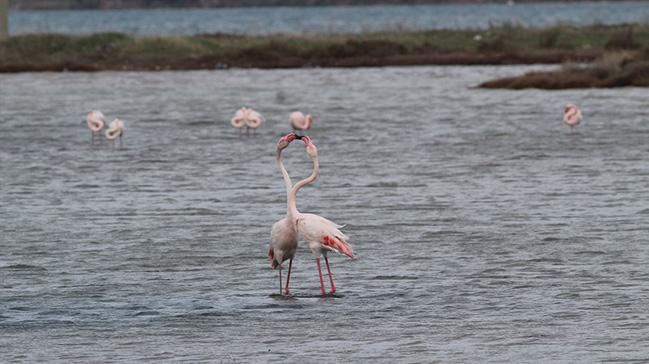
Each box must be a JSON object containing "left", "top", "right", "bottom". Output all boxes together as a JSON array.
[{"left": 268, "top": 133, "right": 354, "bottom": 296}]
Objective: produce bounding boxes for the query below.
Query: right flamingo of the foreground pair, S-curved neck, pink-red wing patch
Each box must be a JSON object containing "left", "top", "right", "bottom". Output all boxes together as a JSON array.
[{"left": 288, "top": 136, "right": 354, "bottom": 296}]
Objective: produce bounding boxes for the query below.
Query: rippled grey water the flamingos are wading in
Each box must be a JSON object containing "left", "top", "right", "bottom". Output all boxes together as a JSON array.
[{"left": 0, "top": 67, "right": 649, "bottom": 363}]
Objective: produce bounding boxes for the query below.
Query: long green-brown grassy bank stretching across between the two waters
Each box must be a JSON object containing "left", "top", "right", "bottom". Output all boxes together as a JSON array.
[{"left": 0, "top": 25, "right": 649, "bottom": 72}]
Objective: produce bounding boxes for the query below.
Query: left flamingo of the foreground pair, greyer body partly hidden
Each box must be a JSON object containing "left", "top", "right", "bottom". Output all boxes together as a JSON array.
[{"left": 268, "top": 133, "right": 297, "bottom": 295}]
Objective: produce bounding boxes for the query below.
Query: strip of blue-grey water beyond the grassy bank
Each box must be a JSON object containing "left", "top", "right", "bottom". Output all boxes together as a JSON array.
[{"left": 9, "top": 1, "right": 649, "bottom": 35}]
